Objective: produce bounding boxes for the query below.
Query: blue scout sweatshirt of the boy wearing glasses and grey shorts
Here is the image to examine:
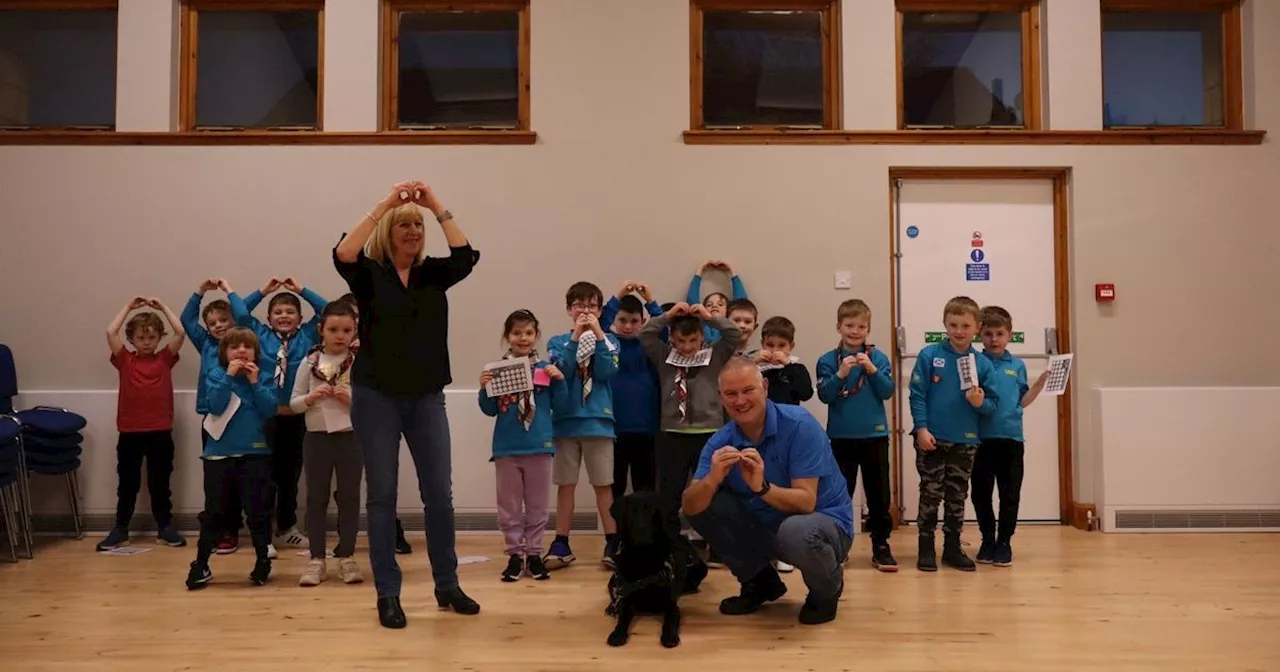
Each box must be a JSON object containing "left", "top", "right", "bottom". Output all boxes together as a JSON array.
[{"left": 547, "top": 332, "right": 621, "bottom": 439}]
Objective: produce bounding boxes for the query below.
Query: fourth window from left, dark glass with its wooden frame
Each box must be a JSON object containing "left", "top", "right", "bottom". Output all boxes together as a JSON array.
[{"left": 690, "top": 0, "right": 841, "bottom": 129}]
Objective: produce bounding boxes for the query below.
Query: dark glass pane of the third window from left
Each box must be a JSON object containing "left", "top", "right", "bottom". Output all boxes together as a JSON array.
[{"left": 397, "top": 12, "right": 520, "bottom": 128}]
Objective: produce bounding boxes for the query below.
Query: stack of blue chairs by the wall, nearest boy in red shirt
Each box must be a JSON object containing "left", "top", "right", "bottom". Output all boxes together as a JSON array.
[{"left": 0, "top": 344, "right": 87, "bottom": 545}]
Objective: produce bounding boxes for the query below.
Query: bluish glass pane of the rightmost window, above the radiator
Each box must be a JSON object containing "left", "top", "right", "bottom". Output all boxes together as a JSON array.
[{"left": 1102, "top": 12, "right": 1226, "bottom": 128}]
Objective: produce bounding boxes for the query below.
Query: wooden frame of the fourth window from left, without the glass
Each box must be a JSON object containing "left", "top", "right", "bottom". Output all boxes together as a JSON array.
[{"left": 689, "top": 0, "right": 844, "bottom": 134}]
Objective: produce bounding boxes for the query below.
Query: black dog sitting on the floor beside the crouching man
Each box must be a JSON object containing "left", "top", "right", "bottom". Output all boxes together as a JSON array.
[{"left": 605, "top": 492, "right": 707, "bottom": 649}]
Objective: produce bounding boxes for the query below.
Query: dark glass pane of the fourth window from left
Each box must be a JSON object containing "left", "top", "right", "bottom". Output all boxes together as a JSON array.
[{"left": 703, "top": 12, "right": 823, "bottom": 128}]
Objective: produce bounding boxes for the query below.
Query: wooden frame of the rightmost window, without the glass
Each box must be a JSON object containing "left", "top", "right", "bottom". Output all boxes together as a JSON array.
[{"left": 1102, "top": 0, "right": 1244, "bottom": 133}]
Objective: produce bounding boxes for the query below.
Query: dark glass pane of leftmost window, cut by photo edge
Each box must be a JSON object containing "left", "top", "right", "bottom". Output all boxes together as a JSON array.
[{"left": 0, "top": 10, "right": 116, "bottom": 128}]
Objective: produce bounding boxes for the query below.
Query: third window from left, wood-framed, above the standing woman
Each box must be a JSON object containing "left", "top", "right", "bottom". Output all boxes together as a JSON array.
[{"left": 383, "top": 0, "right": 530, "bottom": 132}]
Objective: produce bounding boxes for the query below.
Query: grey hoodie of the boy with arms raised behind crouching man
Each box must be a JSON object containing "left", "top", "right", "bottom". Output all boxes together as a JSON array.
[{"left": 640, "top": 315, "right": 742, "bottom": 431}]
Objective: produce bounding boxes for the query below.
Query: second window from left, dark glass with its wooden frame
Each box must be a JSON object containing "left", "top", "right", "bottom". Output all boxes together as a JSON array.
[{"left": 179, "top": 0, "right": 324, "bottom": 131}]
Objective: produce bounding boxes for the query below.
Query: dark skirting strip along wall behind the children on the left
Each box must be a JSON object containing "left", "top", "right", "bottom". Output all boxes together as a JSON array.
[{"left": 23, "top": 511, "right": 599, "bottom": 535}]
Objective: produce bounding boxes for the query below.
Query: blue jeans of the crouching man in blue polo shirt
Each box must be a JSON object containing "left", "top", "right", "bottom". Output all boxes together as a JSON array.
[{"left": 689, "top": 490, "right": 854, "bottom": 598}]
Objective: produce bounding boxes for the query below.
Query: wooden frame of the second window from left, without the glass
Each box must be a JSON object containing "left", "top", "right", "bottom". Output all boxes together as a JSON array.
[{"left": 178, "top": 0, "right": 325, "bottom": 136}]
